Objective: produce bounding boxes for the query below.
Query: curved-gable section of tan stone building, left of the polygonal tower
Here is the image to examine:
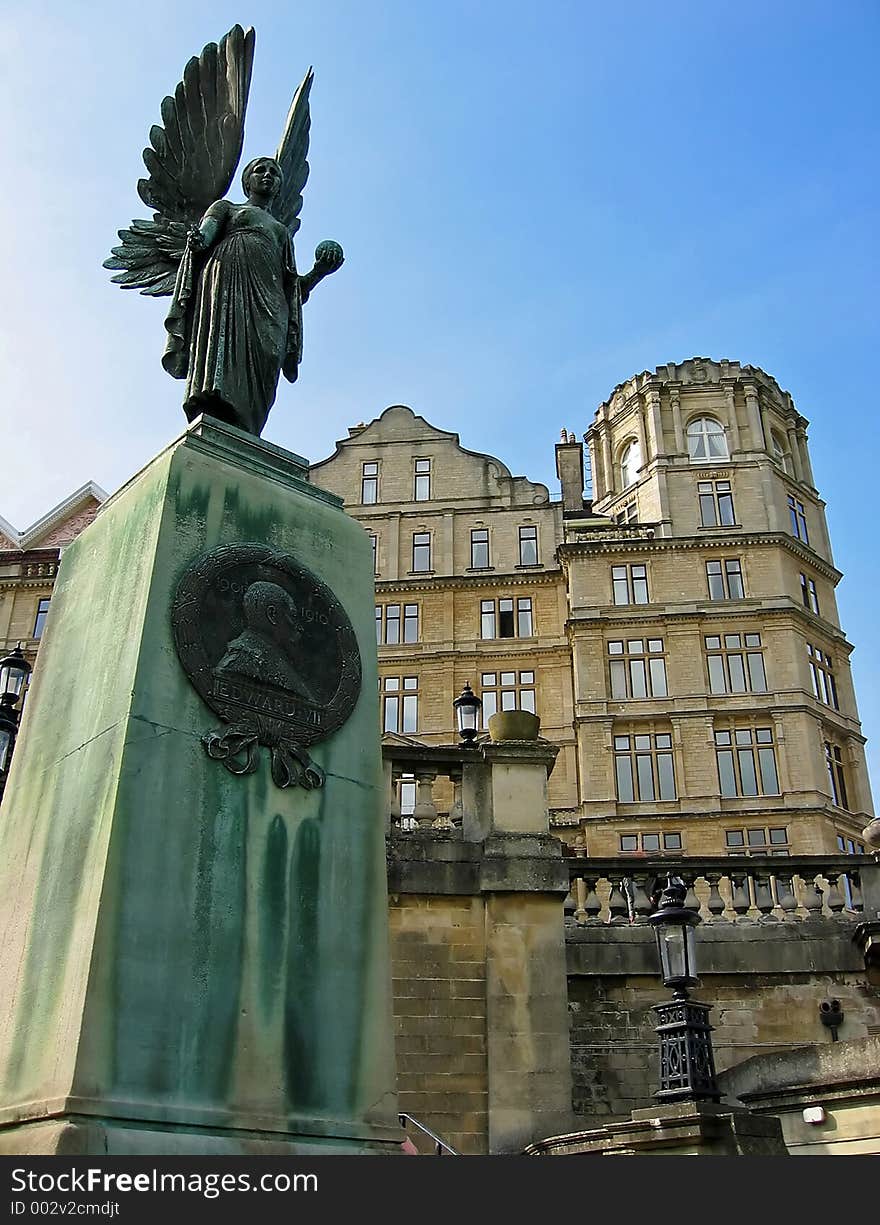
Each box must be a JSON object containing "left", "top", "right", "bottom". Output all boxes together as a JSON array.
[{"left": 310, "top": 405, "right": 578, "bottom": 820}]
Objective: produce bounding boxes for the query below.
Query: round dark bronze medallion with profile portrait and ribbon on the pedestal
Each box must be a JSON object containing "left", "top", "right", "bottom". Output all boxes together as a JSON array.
[{"left": 172, "top": 544, "right": 360, "bottom": 788}]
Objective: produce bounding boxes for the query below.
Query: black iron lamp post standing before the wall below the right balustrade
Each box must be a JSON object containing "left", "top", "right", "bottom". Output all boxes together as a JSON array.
[{"left": 648, "top": 875, "right": 721, "bottom": 1101}]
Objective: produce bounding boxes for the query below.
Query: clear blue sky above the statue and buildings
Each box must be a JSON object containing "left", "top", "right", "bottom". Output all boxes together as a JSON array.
[{"left": 0, "top": 0, "right": 880, "bottom": 790}]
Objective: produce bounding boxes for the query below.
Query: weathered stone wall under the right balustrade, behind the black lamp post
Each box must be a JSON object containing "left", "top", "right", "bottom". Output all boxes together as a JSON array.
[{"left": 566, "top": 919, "right": 880, "bottom": 1128}]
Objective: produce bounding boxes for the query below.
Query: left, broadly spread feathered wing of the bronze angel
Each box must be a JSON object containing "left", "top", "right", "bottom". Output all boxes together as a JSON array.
[{"left": 104, "top": 26, "right": 254, "bottom": 298}]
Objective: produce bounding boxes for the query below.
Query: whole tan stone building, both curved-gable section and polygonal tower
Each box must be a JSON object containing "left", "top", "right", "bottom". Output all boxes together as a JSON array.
[{"left": 311, "top": 358, "right": 871, "bottom": 856}]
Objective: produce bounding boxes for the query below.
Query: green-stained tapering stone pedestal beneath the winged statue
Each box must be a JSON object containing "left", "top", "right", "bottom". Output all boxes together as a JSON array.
[{"left": 0, "top": 418, "right": 402, "bottom": 1154}]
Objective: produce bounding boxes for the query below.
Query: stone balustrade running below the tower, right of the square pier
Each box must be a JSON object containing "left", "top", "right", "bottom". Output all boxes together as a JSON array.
[{"left": 565, "top": 855, "right": 880, "bottom": 926}]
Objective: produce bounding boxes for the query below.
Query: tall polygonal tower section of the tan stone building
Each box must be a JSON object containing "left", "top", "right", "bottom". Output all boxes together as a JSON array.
[{"left": 559, "top": 359, "right": 871, "bottom": 855}]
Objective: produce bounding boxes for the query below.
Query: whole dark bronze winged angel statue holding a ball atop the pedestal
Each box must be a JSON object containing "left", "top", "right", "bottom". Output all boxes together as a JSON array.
[{"left": 104, "top": 26, "right": 343, "bottom": 435}]
